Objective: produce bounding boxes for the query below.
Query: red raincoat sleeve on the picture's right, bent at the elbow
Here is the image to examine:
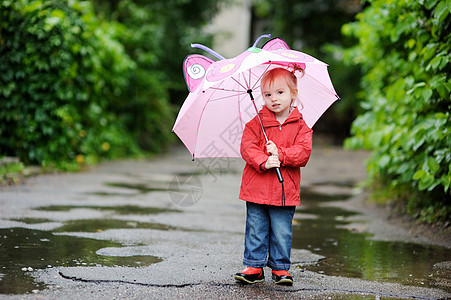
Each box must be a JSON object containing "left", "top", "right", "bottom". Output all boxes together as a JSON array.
[{"left": 278, "top": 119, "right": 313, "bottom": 167}]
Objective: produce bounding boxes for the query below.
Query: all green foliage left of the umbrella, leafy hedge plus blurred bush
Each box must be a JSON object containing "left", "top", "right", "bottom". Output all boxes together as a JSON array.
[{"left": 0, "top": 0, "right": 218, "bottom": 170}]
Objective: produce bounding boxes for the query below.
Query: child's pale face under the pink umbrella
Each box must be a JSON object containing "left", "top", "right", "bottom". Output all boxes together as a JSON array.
[{"left": 262, "top": 76, "right": 297, "bottom": 117}]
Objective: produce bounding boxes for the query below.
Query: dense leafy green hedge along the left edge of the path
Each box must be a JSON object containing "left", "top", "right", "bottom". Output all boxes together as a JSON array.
[{"left": 0, "top": 0, "right": 139, "bottom": 169}]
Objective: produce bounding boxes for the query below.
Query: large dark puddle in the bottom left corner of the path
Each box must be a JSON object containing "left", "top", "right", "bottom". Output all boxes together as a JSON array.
[{"left": 0, "top": 228, "right": 162, "bottom": 294}]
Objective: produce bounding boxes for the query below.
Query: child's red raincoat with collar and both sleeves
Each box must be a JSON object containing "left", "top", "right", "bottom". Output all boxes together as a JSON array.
[{"left": 239, "top": 106, "right": 313, "bottom": 206}]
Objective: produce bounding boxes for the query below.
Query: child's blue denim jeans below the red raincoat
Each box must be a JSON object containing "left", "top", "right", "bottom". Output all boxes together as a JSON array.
[{"left": 243, "top": 202, "right": 296, "bottom": 271}]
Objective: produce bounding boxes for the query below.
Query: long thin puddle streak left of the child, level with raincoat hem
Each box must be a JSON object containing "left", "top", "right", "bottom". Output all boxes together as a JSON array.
[{"left": 34, "top": 205, "right": 181, "bottom": 215}]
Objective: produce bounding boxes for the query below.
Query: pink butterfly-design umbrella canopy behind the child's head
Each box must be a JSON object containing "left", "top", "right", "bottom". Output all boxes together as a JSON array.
[{"left": 173, "top": 39, "right": 339, "bottom": 158}]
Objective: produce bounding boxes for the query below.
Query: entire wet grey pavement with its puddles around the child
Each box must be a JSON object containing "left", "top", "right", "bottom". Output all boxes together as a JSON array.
[{"left": 0, "top": 145, "right": 451, "bottom": 299}]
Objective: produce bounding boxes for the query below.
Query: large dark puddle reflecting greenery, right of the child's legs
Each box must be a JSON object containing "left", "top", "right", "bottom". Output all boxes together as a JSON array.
[{"left": 293, "top": 193, "right": 451, "bottom": 292}]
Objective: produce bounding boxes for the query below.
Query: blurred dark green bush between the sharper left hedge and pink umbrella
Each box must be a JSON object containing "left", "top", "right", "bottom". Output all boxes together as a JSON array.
[{"left": 92, "top": 0, "right": 224, "bottom": 152}]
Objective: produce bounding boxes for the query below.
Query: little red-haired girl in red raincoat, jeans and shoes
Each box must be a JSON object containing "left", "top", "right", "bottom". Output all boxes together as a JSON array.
[{"left": 235, "top": 66, "right": 312, "bottom": 285}]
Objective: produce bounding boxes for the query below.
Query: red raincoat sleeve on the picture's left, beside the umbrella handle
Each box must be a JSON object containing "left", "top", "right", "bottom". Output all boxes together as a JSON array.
[{"left": 240, "top": 121, "right": 268, "bottom": 172}]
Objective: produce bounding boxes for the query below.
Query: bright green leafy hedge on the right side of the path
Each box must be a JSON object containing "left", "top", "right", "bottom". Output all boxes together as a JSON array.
[{"left": 342, "top": 0, "right": 451, "bottom": 222}]
